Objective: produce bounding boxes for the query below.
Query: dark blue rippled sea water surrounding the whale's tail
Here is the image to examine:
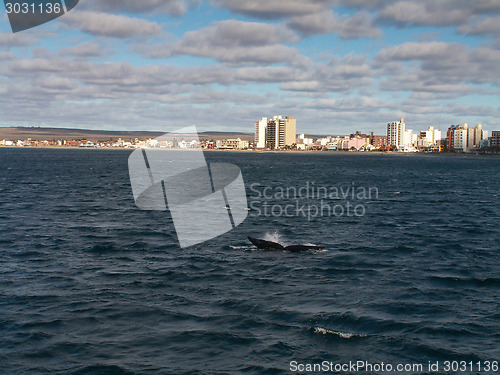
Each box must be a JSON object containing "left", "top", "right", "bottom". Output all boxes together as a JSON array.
[{"left": 0, "top": 149, "right": 500, "bottom": 375}]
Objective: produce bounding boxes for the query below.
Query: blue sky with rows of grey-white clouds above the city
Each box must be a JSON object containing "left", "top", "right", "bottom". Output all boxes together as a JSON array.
[{"left": 0, "top": 0, "right": 500, "bottom": 134}]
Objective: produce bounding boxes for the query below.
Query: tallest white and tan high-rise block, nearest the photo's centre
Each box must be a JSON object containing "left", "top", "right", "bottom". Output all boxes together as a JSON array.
[{"left": 255, "top": 116, "right": 297, "bottom": 149}]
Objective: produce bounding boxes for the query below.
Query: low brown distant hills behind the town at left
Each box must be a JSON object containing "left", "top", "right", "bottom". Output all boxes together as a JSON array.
[{"left": 0, "top": 127, "right": 254, "bottom": 141}]
